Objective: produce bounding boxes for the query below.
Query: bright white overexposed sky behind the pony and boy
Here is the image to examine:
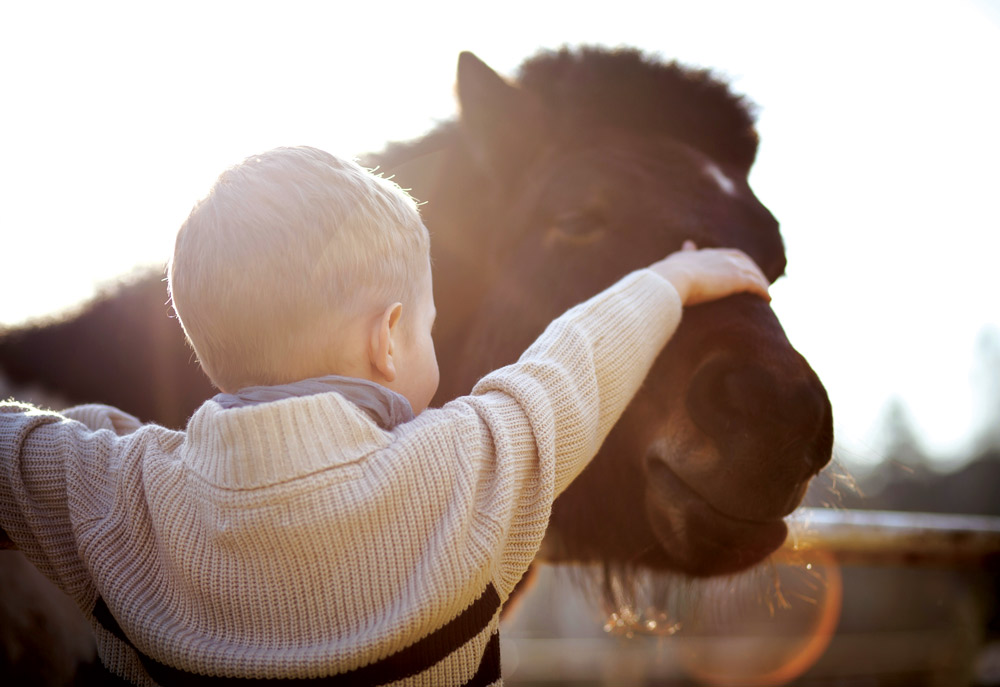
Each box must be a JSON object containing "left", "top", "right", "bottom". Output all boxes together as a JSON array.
[{"left": 0, "top": 0, "right": 1000, "bottom": 462}]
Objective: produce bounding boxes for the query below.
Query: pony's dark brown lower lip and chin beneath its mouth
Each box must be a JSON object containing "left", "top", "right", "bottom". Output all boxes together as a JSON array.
[{"left": 646, "top": 460, "right": 788, "bottom": 577}]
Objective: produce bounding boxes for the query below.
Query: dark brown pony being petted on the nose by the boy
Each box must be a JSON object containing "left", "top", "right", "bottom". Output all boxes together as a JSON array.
[{"left": 0, "top": 49, "right": 833, "bottom": 680}]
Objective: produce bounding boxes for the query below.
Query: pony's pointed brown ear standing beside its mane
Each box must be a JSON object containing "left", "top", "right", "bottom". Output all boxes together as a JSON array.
[{"left": 458, "top": 52, "right": 548, "bottom": 183}]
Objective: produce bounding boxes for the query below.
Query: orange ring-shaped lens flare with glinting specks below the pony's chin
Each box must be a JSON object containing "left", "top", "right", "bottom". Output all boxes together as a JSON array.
[{"left": 604, "top": 548, "right": 843, "bottom": 685}]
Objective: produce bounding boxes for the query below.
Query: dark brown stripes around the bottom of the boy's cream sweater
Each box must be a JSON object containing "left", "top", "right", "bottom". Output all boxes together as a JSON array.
[{"left": 94, "top": 584, "right": 500, "bottom": 687}]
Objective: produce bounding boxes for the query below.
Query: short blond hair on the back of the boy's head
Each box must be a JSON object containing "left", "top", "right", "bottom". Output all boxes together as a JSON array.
[{"left": 168, "top": 147, "right": 430, "bottom": 391}]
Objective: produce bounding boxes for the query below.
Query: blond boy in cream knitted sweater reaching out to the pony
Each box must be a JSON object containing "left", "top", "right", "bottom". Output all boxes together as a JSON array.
[{"left": 0, "top": 148, "right": 767, "bottom": 685}]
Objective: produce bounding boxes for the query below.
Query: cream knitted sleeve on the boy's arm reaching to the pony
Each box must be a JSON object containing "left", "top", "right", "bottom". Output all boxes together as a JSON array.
[{"left": 436, "top": 270, "right": 682, "bottom": 598}]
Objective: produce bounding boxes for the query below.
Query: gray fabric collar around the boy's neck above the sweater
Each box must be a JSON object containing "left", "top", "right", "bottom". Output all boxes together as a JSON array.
[{"left": 212, "top": 375, "right": 414, "bottom": 429}]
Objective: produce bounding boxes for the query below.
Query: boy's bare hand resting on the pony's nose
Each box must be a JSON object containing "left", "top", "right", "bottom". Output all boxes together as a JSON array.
[{"left": 649, "top": 241, "right": 771, "bottom": 305}]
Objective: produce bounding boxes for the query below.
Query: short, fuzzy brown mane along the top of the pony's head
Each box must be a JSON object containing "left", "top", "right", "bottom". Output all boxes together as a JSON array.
[{"left": 517, "top": 47, "right": 758, "bottom": 169}]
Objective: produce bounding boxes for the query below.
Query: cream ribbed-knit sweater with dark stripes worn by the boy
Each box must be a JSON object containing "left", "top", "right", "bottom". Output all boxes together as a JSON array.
[{"left": 0, "top": 270, "right": 681, "bottom": 685}]
